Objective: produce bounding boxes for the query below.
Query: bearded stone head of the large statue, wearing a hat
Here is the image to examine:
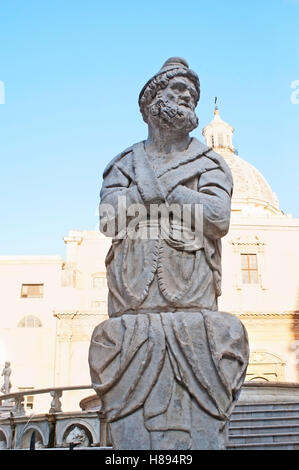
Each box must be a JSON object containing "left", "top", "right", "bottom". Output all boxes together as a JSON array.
[{"left": 139, "top": 57, "right": 200, "bottom": 132}]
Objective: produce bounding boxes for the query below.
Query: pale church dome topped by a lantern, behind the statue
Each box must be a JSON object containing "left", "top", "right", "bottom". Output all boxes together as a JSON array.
[{"left": 202, "top": 107, "right": 281, "bottom": 214}]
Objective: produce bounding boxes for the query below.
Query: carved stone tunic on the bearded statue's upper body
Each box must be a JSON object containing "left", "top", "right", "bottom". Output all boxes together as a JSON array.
[{"left": 101, "top": 138, "right": 233, "bottom": 317}]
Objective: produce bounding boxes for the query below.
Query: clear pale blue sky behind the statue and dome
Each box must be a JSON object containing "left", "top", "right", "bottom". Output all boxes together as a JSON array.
[{"left": 0, "top": 0, "right": 299, "bottom": 255}]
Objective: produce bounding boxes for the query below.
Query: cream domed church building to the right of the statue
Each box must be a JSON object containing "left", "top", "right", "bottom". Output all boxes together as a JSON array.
[{"left": 202, "top": 108, "right": 299, "bottom": 382}]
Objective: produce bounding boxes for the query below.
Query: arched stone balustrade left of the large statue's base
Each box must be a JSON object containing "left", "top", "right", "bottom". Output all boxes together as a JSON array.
[{"left": 0, "top": 385, "right": 109, "bottom": 450}]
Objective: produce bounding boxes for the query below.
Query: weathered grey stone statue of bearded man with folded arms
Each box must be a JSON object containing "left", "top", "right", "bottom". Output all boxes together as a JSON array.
[{"left": 89, "top": 57, "right": 249, "bottom": 449}]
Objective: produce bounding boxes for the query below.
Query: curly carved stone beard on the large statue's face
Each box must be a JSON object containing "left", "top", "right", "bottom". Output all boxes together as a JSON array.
[{"left": 149, "top": 99, "right": 198, "bottom": 132}]
